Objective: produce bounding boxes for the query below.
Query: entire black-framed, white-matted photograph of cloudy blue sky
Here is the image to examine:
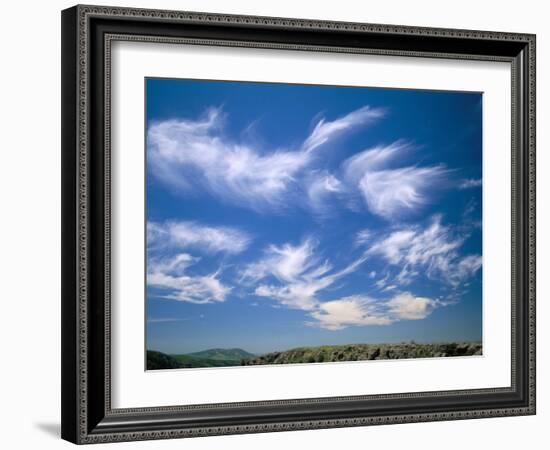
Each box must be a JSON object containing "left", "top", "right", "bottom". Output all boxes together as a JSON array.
[{"left": 62, "top": 6, "right": 535, "bottom": 443}]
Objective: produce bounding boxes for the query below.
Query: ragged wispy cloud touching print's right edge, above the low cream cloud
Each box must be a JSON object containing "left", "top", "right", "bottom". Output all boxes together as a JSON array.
[{"left": 367, "top": 215, "right": 481, "bottom": 287}]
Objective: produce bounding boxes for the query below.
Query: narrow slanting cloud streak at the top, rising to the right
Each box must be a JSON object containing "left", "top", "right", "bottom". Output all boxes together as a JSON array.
[{"left": 302, "top": 106, "right": 385, "bottom": 152}]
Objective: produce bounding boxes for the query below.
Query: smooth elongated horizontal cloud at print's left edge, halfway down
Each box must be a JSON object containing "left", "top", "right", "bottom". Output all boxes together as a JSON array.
[{"left": 147, "top": 220, "right": 252, "bottom": 253}]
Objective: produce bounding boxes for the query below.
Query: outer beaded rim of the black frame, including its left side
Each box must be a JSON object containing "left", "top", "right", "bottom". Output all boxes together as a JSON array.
[{"left": 62, "top": 5, "right": 535, "bottom": 444}]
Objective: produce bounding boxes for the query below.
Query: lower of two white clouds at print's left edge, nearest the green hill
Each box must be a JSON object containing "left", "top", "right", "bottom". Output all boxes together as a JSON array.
[{"left": 147, "top": 253, "right": 231, "bottom": 304}]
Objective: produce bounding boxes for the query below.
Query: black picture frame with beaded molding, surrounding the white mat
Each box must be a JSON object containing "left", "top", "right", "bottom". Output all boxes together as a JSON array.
[{"left": 61, "top": 5, "right": 535, "bottom": 444}]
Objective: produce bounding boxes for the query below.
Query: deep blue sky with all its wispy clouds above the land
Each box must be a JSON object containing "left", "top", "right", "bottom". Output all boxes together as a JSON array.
[{"left": 146, "top": 79, "right": 482, "bottom": 353}]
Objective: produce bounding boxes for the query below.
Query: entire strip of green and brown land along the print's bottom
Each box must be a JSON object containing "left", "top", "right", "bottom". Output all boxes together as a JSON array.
[{"left": 147, "top": 342, "right": 482, "bottom": 370}]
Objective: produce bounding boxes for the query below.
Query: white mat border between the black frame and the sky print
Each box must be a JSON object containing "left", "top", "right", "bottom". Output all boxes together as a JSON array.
[{"left": 111, "top": 41, "right": 511, "bottom": 408}]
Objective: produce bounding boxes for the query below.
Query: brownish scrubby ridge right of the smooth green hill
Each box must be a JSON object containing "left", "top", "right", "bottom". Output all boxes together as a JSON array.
[{"left": 242, "top": 342, "right": 482, "bottom": 365}]
